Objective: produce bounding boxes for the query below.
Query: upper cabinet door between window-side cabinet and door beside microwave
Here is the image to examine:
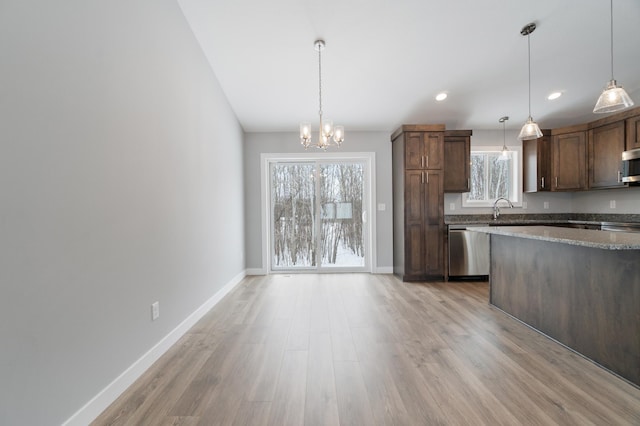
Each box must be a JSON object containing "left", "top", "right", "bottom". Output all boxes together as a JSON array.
[{"left": 551, "top": 131, "right": 587, "bottom": 191}]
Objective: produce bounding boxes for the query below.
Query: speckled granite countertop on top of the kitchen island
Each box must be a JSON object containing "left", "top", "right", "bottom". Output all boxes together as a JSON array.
[{"left": 469, "top": 226, "right": 640, "bottom": 250}]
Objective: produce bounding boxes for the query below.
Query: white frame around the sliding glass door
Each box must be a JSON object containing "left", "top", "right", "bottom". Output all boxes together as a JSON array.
[{"left": 260, "top": 152, "right": 376, "bottom": 274}]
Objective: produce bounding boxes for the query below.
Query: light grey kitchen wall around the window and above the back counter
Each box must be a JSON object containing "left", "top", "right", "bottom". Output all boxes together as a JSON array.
[{"left": 444, "top": 129, "right": 640, "bottom": 215}]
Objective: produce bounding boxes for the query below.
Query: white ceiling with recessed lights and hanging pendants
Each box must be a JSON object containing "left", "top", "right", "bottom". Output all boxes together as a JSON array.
[{"left": 178, "top": 0, "right": 640, "bottom": 136}]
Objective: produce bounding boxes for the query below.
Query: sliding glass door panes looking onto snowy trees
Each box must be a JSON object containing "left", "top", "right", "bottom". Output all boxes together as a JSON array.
[{"left": 269, "top": 160, "right": 368, "bottom": 272}]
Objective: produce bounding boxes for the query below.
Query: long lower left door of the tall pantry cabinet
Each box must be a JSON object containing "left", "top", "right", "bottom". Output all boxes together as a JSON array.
[{"left": 404, "top": 170, "right": 426, "bottom": 280}]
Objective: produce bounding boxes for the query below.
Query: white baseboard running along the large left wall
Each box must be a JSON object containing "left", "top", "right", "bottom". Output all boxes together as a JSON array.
[{"left": 63, "top": 271, "right": 247, "bottom": 426}]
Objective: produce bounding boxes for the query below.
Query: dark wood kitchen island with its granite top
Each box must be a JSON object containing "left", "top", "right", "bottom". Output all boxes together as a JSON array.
[{"left": 474, "top": 226, "right": 640, "bottom": 386}]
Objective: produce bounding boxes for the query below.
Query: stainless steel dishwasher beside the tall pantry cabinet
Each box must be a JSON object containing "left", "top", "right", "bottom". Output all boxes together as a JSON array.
[{"left": 449, "top": 225, "right": 489, "bottom": 278}]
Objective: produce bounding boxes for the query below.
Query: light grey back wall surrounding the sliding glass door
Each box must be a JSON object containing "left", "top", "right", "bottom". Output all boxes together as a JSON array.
[{"left": 244, "top": 131, "right": 393, "bottom": 271}]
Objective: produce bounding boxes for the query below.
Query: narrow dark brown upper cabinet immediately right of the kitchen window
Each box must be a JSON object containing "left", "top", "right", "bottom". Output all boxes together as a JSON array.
[{"left": 522, "top": 130, "right": 552, "bottom": 192}]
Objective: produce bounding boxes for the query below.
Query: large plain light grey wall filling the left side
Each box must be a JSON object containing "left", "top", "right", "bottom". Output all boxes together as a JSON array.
[{"left": 0, "top": 0, "right": 244, "bottom": 425}]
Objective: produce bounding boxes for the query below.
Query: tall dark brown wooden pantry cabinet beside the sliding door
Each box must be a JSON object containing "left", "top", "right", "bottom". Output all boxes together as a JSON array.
[{"left": 391, "top": 124, "right": 445, "bottom": 281}]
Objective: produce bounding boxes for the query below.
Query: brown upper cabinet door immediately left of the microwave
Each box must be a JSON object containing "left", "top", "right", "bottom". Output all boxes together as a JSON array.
[{"left": 589, "top": 121, "right": 625, "bottom": 188}]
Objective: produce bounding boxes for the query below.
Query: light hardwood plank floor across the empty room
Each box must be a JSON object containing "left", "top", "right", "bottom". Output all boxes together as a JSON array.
[{"left": 94, "top": 274, "right": 640, "bottom": 426}]
